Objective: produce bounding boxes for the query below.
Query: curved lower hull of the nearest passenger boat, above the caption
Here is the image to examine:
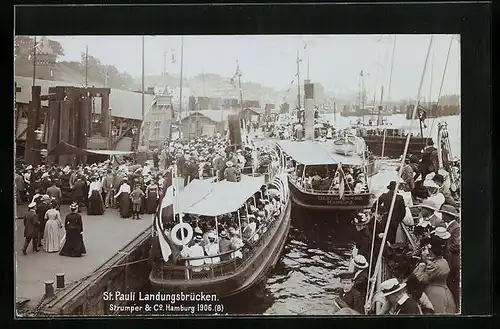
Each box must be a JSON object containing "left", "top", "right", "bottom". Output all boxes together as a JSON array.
[{"left": 149, "top": 200, "right": 292, "bottom": 298}]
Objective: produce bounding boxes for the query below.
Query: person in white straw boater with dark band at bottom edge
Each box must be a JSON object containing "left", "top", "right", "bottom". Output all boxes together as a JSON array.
[{"left": 380, "top": 278, "right": 422, "bottom": 315}]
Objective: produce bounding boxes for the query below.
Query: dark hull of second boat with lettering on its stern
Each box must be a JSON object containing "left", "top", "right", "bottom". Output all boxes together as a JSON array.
[{"left": 288, "top": 180, "right": 373, "bottom": 210}]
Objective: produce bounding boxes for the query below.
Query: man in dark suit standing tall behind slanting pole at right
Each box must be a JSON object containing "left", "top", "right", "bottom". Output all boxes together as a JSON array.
[{"left": 372, "top": 181, "right": 406, "bottom": 244}]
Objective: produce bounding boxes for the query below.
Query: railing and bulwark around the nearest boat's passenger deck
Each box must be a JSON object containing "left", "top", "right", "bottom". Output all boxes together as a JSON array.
[{"left": 153, "top": 204, "right": 286, "bottom": 281}]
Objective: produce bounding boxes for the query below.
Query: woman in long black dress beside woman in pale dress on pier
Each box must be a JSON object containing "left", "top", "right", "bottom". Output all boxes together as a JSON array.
[{"left": 59, "top": 203, "right": 87, "bottom": 257}]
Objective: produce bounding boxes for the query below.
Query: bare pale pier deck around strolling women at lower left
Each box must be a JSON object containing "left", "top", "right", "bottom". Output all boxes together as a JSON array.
[{"left": 14, "top": 205, "right": 153, "bottom": 301}]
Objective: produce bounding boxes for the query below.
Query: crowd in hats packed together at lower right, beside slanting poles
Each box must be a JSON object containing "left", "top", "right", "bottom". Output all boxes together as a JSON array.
[{"left": 339, "top": 161, "right": 460, "bottom": 314}]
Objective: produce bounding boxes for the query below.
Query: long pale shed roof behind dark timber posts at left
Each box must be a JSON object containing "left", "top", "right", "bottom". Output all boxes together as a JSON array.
[{"left": 14, "top": 76, "right": 154, "bottom": 120}]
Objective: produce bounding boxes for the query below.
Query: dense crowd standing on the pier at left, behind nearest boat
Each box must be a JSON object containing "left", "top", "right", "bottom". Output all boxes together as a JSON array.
[{"left": 15, "top": 134, "right": 277, "bottom": 254}]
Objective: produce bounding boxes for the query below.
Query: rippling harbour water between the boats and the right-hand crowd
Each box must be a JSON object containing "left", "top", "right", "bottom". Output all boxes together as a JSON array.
[{"left": 134, "top": 115, "right": 460, "bottom": 315}]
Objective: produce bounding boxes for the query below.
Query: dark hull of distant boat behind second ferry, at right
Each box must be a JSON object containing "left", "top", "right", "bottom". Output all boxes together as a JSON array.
[{"left": 363, "top": 135, "right": 432, "bottom": 158}]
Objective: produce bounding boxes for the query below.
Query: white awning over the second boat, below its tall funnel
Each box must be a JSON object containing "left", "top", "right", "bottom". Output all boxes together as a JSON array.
[{"left": 278, "top": 140, "right": 363, "bottom": 166}]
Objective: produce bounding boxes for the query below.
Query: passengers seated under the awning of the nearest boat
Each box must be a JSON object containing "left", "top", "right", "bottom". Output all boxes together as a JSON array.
[{"left": 151, "top": 182, "right": 286, "bottom": 272}]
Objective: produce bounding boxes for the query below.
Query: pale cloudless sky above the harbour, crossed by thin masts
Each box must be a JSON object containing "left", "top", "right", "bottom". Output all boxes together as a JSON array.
[{"left": 48, "top": 34, "right": 460, "bottom": 100}]
